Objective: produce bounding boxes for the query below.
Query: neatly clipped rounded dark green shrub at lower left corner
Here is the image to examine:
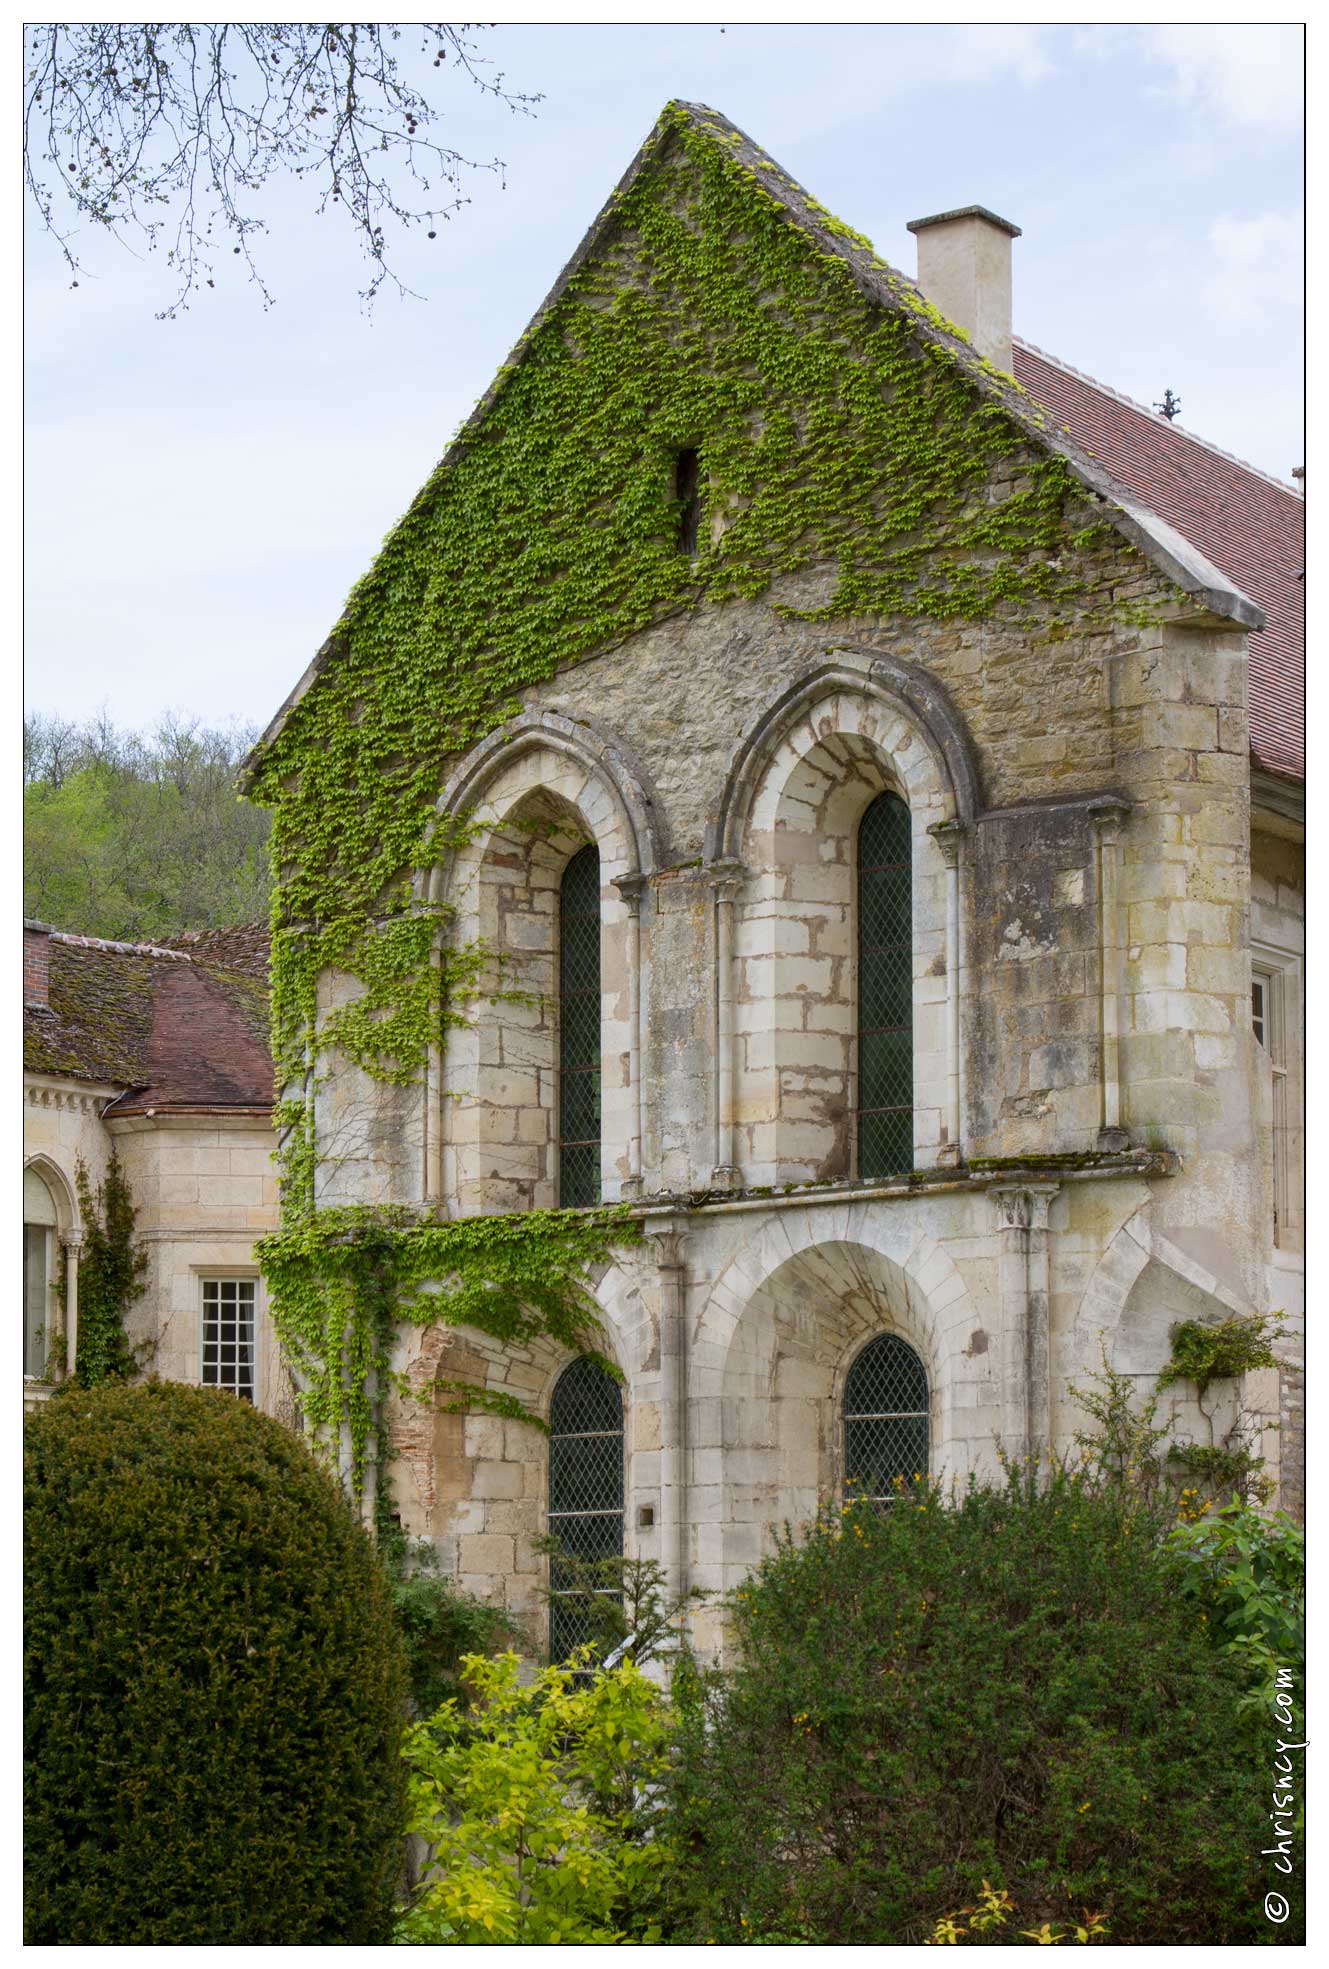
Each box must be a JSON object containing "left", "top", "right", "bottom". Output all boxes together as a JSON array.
[{"left": 24, "top": 1382, "right": 406, "bottom": 1943}]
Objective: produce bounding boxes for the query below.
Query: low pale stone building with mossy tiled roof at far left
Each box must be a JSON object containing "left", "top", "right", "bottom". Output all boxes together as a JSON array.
[{"left": 24, "top": 923, "right": 289, "bottom": 1408}]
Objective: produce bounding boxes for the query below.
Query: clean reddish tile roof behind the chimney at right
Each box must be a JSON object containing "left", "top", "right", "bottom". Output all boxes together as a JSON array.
[{"left": 1014, "top": 341, "right": 1305, "bottom": 780}]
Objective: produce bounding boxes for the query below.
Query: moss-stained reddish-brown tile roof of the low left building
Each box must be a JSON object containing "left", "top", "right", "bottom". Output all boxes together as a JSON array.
[{"left": 24, "top": 925, "right": 274, "bottom": 1114}]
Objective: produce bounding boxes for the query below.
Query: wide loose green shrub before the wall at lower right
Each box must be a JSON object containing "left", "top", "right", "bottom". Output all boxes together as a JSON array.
[{"left": 671, "top": 1473, "right": 1268, "bottom": 1945}]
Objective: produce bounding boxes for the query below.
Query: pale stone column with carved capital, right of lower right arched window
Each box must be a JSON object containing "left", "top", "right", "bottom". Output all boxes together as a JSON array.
[{"left": 988, "top": 1181, "right": 1061, "bottom": 1459}]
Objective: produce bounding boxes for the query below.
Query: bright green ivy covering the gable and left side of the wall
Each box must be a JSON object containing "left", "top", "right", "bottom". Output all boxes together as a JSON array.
[{"left": 250, "top": 104, "right": 1173, "bottom": 1496}]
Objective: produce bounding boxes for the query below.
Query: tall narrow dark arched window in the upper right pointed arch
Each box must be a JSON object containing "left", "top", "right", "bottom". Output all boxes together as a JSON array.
[{"left": 858, "top": 794, "right": 914, "bottom": 1175}]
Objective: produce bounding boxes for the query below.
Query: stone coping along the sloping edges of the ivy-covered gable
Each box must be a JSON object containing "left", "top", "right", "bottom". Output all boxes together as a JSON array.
[{"left": 240, "top": 100, "right": 1264, "bottom": 792}]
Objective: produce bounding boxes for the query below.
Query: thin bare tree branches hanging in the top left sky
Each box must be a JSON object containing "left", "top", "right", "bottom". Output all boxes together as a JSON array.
[{"left": 24, "top": 22, "right": 539, "bottom": 319}]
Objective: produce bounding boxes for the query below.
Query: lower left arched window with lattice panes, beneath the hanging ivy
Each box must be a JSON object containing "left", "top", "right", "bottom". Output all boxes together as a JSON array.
[{"left": 549, "top": 1359, "right": 622, "bottom": 1662}]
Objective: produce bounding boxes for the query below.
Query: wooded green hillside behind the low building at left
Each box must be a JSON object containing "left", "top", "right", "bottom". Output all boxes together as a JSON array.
[{"left": 24, "top": 713, "right": 268, "bottom": 941}]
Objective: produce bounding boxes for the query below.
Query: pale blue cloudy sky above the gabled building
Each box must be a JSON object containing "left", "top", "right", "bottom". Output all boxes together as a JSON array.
[{"left": 26, "top": 26, "right": 1303, "bottom": 740}]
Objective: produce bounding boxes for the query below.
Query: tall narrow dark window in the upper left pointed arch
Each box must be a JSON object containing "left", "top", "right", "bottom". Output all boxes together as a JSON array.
[{"left": 559, "top": 847, "right": 601, "bottom": 1211}]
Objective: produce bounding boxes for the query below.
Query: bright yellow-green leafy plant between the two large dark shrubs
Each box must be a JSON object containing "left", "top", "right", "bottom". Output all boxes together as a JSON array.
[{"left": 396, "top": 1650, "right": 669, "bottom": 1943}]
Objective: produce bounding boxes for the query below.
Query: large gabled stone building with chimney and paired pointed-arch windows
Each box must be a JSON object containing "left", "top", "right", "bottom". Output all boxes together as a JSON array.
[{"left": 250, "top": 104, "right": 1303, "bottom": 1644}]
